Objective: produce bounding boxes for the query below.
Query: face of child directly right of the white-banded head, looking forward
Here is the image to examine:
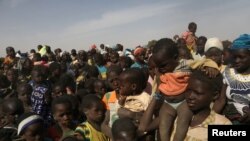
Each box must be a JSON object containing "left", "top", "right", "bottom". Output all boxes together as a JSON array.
[{"left": 53, "top": 103, "right": 72, "bottom": 127}]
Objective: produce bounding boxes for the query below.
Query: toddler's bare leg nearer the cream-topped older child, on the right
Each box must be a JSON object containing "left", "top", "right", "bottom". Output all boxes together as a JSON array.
[{"left": 174, "top": 101, "right": 193, "bottom": 141}]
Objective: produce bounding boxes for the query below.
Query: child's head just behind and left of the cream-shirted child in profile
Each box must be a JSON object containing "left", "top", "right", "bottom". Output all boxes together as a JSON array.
[{"left": 107, "top": 65, "right": 122, "bottom": 90}]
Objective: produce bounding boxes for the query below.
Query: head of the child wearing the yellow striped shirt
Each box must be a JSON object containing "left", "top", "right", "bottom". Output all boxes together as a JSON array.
[{"left": 81, "top": 95, "right": 105, "bottom": 124}]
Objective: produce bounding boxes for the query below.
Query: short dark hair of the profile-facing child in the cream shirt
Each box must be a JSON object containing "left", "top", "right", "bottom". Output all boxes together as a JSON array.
[{"left": 121, "top": 68, "right": 147, "bottom": 93}]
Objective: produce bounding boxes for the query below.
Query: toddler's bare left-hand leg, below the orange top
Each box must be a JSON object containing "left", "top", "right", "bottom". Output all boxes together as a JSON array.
[{"left": 159, "top": 102, "right": 177, "bottom": 141}]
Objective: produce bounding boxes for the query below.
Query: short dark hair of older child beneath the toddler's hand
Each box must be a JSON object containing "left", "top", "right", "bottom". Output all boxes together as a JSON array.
[{"left": 189, "top": 70, "right": 223, "bottom": 92}]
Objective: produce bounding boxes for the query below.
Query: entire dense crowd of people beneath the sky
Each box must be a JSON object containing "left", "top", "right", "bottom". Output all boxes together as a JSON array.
[{"left": 0, "top": 22, "right": 250, "bottom": 141}]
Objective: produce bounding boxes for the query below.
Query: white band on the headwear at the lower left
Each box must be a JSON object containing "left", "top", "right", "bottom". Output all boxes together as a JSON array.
[{"left": 17, "top": 115, "right": 43, "bottom": 135}]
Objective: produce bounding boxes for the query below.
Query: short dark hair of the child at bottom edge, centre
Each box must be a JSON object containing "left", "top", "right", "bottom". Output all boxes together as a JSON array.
[{"left": 111, "top": 118, "right": 137, "bottom": 140}]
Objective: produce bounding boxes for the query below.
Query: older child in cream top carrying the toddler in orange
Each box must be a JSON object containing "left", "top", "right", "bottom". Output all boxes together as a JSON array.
[{"left": 172, "top": 70, "right": 231, "bottom": 141}]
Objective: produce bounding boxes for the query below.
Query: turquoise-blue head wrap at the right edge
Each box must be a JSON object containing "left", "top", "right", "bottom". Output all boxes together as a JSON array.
[{"left": 232, "top": 34, "right": 250, "bottom": 49}]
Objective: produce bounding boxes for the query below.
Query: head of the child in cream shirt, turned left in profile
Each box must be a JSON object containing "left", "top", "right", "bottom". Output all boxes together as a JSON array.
[{"left": 119, "top": 68, "right": 147, "bottom": 96}]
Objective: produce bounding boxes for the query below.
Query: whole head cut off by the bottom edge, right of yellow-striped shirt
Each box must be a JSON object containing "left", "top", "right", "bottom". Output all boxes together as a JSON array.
[{"left": 111, "top": 118, "right": 137, "bottom": 141}]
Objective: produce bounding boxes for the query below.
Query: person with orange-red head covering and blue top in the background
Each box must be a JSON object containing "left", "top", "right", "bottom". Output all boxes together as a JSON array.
[{"left": 131, "top": 46, "right": 148, "bottom": 68}]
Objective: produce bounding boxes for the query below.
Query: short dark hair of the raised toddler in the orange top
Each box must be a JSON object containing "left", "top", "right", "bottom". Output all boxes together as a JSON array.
[{"left": 152, "top": 38, "right": 178, "bottom": 58}]
